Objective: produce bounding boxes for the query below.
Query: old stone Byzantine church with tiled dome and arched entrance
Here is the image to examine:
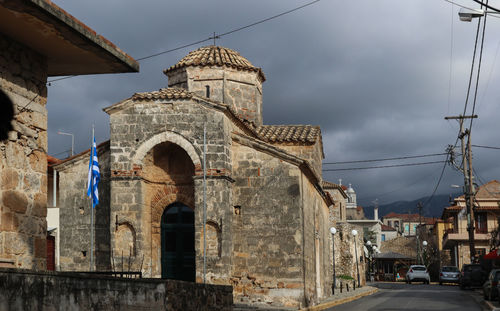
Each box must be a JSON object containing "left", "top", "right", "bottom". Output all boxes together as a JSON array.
[{"left": 54, "top": 46, "right": 345, "bottom": 307}]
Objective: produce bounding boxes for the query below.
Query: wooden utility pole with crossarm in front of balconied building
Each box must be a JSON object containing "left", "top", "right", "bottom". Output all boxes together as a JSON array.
[{"left": 445, "top": 115, "right": 477, "bottom": 263}]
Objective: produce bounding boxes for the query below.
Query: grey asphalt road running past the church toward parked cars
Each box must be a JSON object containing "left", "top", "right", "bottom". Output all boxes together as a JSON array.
[{"left": 327, "top": 283, "right": 483, "bottom": 311}]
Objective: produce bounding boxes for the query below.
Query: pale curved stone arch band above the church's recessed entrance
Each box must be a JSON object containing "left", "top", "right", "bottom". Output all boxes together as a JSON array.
[{"left": 132, "top": 131, "right": 201, "bottom": 170}]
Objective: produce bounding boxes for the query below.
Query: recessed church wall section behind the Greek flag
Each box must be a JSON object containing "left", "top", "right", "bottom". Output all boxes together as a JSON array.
[{"left": 55, "top": 143, "right": 111, "bottom": 271}]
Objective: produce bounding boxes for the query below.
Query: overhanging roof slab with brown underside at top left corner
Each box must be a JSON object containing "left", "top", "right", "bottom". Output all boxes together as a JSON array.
[{"left": 0, "top": 0, "right": 139, "bottom": 76}]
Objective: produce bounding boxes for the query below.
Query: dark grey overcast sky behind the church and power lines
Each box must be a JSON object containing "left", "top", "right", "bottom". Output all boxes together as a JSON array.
[{"left": 48, "top": 0, "right": 500, "bottom": 212}]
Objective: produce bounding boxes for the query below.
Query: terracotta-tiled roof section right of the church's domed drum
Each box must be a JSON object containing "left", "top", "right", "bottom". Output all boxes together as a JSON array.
[{"left": 257, "top": 125, "right": 321, "bottom": 143}]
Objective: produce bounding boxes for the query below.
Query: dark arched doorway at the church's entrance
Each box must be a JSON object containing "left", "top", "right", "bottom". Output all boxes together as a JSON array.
[{"left": 161, "top": 202, "right": 196, "bottom": 282}]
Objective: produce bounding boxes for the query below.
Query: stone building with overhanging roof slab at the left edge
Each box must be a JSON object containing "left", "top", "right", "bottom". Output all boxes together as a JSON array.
[{"left": 0, "top": 0, "right": 139, "bottom": 269}]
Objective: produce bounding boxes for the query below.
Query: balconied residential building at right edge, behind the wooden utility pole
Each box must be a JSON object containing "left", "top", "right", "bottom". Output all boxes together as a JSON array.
[{"left": 442, "top": 180, "right": 500, "bottom": 267}]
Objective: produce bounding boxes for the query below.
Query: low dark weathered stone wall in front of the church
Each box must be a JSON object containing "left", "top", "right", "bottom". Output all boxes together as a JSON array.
[{"left": 0, "top": 269, "right": 233, "bottom": 311}]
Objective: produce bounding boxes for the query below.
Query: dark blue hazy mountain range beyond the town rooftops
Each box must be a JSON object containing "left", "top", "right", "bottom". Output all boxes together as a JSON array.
[{"left": 363, "top": 193, "right": 460, "bottom": 219}]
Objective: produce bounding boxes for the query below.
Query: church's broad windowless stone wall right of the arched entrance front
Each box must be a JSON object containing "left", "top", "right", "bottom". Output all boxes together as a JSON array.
[{"left": 232, "top": 143, "right": 304, "bottom": 307}]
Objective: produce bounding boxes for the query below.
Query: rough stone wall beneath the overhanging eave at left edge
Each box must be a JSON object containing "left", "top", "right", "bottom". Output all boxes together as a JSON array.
[{"left": 0, "top": 34, "right": 47, "bottom": 270}]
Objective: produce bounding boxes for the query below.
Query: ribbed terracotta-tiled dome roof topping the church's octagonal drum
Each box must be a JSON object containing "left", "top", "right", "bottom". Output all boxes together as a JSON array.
[{"left": 163, "top": 45, "right": 266, "bottom": 82}]
